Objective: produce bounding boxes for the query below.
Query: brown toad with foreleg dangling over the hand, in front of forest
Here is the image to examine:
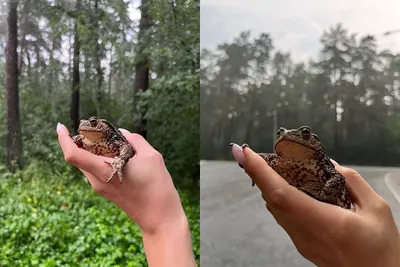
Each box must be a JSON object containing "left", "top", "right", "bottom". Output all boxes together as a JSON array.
[{"left": 72, "top": 117, "right": 135, "bottom": 183}]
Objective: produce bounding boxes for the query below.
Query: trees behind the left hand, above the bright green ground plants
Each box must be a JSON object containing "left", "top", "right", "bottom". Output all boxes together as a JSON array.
[{"left": 0, "top": 0, "right": 200, "bottom": 187}]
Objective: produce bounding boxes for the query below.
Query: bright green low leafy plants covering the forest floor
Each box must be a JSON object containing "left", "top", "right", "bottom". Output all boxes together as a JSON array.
[{"left": 0, "top": 161, "right": 200, "bottom": 267}]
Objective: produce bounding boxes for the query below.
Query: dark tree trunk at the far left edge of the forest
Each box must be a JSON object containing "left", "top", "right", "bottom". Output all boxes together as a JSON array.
[{"left": 6, "top": 0, "right": 22, "bottom": 172}]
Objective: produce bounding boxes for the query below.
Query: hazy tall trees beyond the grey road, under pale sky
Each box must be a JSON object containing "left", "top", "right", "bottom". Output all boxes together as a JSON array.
[{"left": 200, "top": 24, "right": 400, "bottom": 166}]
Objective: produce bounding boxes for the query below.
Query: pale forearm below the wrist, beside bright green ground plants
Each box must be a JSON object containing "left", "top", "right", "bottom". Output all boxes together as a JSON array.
[{"left": 143, "top": 213, "right": 196, "bottom": 267}]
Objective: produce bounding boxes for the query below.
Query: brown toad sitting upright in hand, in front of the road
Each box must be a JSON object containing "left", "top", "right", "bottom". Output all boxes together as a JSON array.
[{"left": 234, "top": 126, "right": 352, "bottom": 209}]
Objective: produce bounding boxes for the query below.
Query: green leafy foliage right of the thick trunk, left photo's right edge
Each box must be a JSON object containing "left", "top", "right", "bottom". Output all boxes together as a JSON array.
[{"left": 136, "top": 0, "right": 200, "bottom": 187}]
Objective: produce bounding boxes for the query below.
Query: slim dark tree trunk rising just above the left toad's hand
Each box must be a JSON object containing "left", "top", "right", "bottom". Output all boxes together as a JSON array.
[{"left": 70, "top": 0, "right": 81, "bottom": 134}]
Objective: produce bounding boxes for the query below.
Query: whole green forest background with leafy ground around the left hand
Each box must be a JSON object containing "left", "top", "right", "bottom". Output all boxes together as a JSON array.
[{"left": 0, "top": 0, "right": 200, "bottom": 266}]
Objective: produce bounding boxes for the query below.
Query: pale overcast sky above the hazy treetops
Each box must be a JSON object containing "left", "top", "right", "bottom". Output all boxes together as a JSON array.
[{"left": 200, "top": 0, "right": 400, "bottom": 60}]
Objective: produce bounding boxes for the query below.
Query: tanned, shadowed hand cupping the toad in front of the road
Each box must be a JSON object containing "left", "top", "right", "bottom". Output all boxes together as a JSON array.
[{"left": 234, "top": 147, "right": 400, "bottom": 267}]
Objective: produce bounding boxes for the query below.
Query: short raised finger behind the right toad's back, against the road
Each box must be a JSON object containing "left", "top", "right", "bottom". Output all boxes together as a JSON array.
[{"left": 336, "top": 166, "right": 379, "bottom": 209}]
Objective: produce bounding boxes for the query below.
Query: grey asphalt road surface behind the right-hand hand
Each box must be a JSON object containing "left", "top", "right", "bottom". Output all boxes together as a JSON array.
[{"left": 200, "top": 161, "right": 400, "bottom": 267}]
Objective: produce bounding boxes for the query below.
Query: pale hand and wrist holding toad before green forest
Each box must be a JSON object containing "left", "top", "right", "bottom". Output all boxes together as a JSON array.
[{"left": 57, "top": 124, "right": 196, "bottom": 267}]
